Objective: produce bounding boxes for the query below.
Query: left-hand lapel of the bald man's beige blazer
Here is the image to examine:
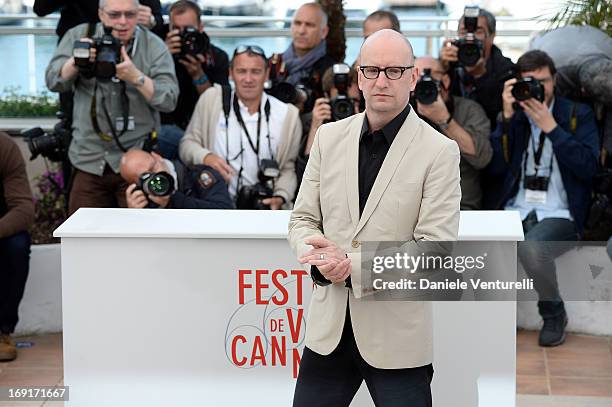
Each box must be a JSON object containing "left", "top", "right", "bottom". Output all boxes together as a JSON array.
[{"left": 345, "top": 113, "right": 365, "bottom": 231}]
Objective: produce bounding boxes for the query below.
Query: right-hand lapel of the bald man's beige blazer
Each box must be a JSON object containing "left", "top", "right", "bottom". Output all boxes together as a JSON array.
[{"left": 354, "top": 108, "right": 419, "bottom": 235}]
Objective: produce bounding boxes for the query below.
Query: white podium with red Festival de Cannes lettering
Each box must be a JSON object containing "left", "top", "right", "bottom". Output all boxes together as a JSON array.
[{"left": 55, "top": 209, "right": 523, "bottom": 407}]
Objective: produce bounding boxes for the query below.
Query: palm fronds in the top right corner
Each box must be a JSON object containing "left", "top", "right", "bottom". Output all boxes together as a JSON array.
[{"left": 550, "top": 0, "right": 612, "bottom": 35}]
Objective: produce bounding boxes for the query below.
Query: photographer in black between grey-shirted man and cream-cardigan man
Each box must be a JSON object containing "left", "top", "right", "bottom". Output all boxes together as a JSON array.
[{"left": 159, "top": 0, "right": 229, "bottom": 159}]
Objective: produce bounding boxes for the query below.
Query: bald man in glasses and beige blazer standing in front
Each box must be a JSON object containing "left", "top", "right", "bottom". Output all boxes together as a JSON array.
[{"left": 289, "top": 29, "right": 461, "bottom": 407}]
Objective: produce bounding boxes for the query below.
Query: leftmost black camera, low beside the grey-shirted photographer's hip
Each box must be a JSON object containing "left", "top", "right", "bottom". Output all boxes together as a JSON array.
[{"left": 23, "top": 112, "right": 72, "bottom": 162}]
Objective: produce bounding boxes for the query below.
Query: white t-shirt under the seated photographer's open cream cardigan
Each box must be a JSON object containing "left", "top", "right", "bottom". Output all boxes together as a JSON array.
[{"left": 213, "top": 92, "right": 289, "bottom": 199}]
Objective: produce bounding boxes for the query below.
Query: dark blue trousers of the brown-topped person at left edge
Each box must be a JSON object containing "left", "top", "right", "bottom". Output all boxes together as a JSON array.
[{"left": 0, "top": 232, "right": 30, "bottom": 334}]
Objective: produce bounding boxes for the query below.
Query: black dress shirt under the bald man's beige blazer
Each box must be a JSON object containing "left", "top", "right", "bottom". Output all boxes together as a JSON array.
[{"left": 310, "top": 104, "right": 410, "bottom": 287}]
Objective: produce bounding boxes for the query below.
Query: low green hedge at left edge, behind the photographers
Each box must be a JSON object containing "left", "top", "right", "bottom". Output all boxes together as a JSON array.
[{"left": 0, "top": 87, "right": 59, "bottom": 117}]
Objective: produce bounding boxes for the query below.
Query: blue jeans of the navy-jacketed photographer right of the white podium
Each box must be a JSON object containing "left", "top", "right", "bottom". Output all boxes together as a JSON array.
[{"left": 518, "top": 211, "right": 578, "bottom": 318}]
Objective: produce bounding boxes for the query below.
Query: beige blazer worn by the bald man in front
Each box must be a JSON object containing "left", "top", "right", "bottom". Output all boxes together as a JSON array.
[{"left": 289, "top": 110, "right": 461, "bottom": 369}]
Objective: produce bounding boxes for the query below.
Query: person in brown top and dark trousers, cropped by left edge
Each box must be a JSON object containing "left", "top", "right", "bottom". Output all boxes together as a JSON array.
[{"left": 0, "top": 132, "right": 34, "bottom": 362}]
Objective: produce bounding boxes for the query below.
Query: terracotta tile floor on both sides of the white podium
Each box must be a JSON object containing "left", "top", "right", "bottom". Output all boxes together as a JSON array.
[{"left": 0, "top": 331, "right": 612, "bottom": 407}]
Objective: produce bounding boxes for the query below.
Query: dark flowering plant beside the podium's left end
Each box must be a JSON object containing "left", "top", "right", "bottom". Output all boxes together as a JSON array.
[{"left": 32, "top": 164, "right": 67, "bottom": 244}]
